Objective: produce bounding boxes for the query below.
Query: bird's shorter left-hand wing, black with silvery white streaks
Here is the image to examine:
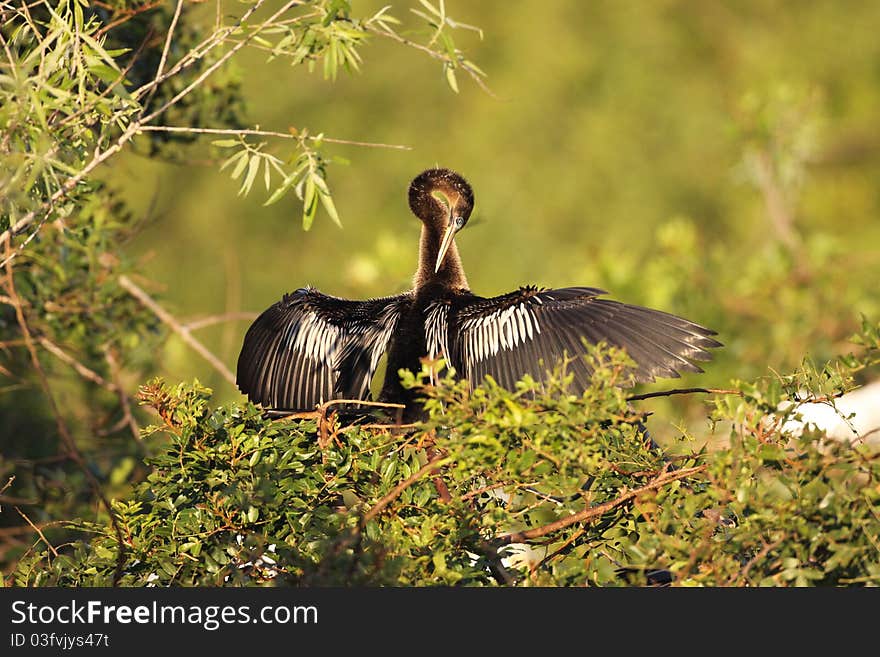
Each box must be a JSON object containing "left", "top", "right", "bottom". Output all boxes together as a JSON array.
[{"left": 236, "top": 287, "right": 412, "bottom": 410}]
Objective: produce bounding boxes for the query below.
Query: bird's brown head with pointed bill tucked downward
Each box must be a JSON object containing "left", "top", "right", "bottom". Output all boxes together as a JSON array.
[{"left": 409, "top": 169, "right": 474, "bottom": 272}]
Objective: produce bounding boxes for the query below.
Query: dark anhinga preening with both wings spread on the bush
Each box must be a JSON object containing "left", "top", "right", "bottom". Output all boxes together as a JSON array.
[{"left": 237, "top": 168, "right": 721, "bottom": 417}]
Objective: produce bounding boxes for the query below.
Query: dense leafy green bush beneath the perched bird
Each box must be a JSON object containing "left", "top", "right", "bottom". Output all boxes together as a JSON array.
[{"left": 15, "top": 326, "right": 880, "bottom": 586}]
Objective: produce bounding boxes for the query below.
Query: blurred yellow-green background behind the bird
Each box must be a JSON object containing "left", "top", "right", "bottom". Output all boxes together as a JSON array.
[{"left": 117, "top": 0, "right": 880, "bottom": 434}]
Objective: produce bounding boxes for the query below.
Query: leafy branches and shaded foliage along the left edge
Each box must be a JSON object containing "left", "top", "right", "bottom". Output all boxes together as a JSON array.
[{"left": 0, "top": 0, "right": 479, "bottom": 566}]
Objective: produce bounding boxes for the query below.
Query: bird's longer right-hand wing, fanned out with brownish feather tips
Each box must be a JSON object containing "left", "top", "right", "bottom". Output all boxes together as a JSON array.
[{"left": 426, "top": 287, "right": 721, "bottom": 391}]
